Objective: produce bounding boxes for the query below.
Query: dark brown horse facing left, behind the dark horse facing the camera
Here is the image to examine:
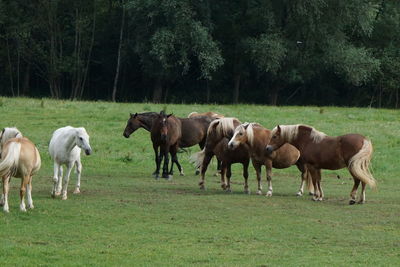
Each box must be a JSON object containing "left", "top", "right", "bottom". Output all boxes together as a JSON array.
[{"left": 123, "top": 112, "right": 219, "bottom": 176}]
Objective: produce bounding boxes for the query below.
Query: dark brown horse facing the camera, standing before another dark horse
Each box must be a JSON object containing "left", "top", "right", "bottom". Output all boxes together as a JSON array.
[{"left": 150, "top": 111, "right": 182, "bottom": 179}]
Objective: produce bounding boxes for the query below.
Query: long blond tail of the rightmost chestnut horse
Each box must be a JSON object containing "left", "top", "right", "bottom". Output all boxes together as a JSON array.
[{"left": 348, "top": 139, "right": 376, "bottom": 188}]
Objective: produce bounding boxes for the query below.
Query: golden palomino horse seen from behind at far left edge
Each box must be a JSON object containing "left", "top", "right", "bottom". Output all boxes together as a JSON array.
[{"left": 0, "top": 128, "right": 41, "bottom": 212}]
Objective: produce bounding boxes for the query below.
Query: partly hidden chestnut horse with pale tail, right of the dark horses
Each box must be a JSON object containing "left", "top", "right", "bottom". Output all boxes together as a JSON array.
[{"left": 190, "top": 118, "right": 241, "bottom": 190}]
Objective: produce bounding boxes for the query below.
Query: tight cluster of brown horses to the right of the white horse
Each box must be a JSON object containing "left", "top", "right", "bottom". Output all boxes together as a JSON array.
[{"left": 123, "top": 111, "right": 376, "bottom": 204}]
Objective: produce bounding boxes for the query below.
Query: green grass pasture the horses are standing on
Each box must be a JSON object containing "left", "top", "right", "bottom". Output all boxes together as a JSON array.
[{"left": 0, "top": 98, "right": 400, "bottom": 266}]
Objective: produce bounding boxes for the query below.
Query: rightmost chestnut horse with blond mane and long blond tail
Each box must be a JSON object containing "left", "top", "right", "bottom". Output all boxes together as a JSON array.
[{"left": 266, "top": 125, "right": 376, "bottom": 205}]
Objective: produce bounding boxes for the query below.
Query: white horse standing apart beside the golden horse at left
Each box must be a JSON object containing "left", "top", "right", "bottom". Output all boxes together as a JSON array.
[{"left": 49, "top": 126, "right": 92, "bottom": 200}]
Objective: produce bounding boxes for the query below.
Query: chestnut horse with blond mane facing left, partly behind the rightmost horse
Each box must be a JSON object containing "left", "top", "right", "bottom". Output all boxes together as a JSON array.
[{"left": 229, "top": 123, "right": 311, "bottom": 196}]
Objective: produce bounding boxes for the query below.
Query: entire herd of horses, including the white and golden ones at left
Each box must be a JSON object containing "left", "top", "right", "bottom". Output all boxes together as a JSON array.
[{"left": 0, "top": 111, "right": 376, "bottom": 212}]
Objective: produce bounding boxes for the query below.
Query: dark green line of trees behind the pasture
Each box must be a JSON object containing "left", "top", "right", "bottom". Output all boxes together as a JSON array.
[{"left": 0, "top": 0, "right": 400, "bottom": 108}]
